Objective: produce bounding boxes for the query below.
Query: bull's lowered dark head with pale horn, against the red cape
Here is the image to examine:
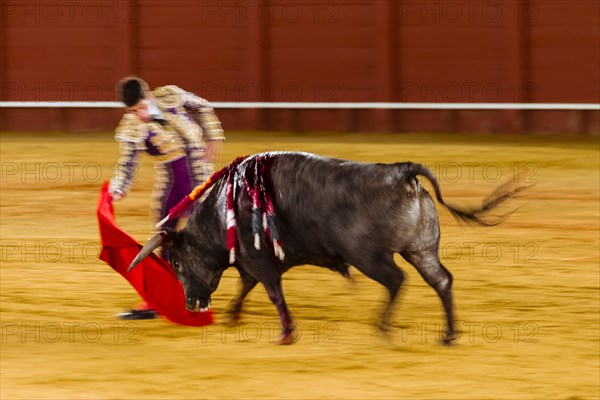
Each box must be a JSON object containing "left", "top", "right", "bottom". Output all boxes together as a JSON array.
[{"left": 128, "top": 229, "right": 225, "bottom": 312}]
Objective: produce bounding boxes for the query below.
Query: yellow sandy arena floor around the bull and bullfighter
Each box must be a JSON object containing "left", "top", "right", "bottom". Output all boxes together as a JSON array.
[{"left": 0, "top": 132, "right": 600, "bottom": 400}]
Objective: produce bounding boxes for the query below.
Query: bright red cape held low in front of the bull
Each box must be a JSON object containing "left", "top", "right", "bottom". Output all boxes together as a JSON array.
[{"left": 96, "top": 182, "right": 214, "bottom": 326}]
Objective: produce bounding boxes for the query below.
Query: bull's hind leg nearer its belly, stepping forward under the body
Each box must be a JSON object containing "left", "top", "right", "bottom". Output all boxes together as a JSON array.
[{"left": 353, "top": 253, "right": 404, "bottom": 334}]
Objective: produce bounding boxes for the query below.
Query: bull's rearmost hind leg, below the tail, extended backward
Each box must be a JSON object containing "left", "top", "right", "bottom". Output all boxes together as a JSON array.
[{"left": 401, "top": 249, "right": 456, "bottom": 344}]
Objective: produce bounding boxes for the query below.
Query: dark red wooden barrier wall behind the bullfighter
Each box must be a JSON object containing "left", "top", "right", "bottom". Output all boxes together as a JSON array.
[{"left": 0, "top": 0, "right": 600, "bottom": 134}]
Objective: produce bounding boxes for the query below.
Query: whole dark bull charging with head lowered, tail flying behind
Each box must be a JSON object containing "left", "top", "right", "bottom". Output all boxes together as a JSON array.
[{"left": 131, "top": 152, "right": 523, "bottom": 343}]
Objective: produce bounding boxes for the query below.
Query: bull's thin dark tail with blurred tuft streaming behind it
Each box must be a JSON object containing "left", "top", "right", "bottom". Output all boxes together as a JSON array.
[{"left": 405, "top": 163, "right": 530, "bottom": 226}]
